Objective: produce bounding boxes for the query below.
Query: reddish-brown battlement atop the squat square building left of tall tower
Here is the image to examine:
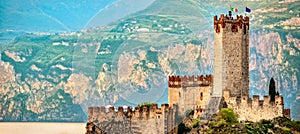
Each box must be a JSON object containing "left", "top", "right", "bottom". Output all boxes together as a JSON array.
[{"left": 168, "top": 75, "right": 213, "bottom": 88}]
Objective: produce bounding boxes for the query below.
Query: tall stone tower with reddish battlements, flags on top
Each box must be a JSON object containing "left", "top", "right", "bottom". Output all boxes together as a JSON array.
[{"left": 213, "top": 11, "right": 249, "bottom": 97}]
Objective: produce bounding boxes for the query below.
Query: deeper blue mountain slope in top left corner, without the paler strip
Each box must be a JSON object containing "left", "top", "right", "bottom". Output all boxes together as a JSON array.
[{"left": 0, "top": 0, "right": 114, "bottom": 32}]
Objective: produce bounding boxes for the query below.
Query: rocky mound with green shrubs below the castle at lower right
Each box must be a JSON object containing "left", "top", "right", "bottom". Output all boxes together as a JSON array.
[{"left": 178, "top": 108, "right": 300, "bottom": 134}]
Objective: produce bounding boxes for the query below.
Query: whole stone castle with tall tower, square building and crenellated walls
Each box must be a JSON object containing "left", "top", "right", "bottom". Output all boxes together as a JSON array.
[{"left": 86, "top": 13, "right": 290, "bottom": 134}]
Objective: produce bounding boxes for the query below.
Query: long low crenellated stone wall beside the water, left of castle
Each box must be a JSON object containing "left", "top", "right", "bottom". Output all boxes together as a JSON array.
[{"left": 88, "top": 104, "right": 177, "bottom": 134}]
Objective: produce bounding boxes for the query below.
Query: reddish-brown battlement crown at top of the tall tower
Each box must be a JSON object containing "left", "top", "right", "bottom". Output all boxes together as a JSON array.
[{"left": 214, "top": 14, "right": 249, "bottom": 33}]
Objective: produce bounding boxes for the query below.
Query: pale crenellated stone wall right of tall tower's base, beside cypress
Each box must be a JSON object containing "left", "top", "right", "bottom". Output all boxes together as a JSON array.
[{"left": 223, "top": 91, "right": 284, "bottom": 122}]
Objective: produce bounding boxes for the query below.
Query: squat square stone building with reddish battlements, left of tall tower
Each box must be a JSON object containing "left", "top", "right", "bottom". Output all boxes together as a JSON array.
[{"left": 168, "top": 75, "right": 213, "bottom": 115}]
